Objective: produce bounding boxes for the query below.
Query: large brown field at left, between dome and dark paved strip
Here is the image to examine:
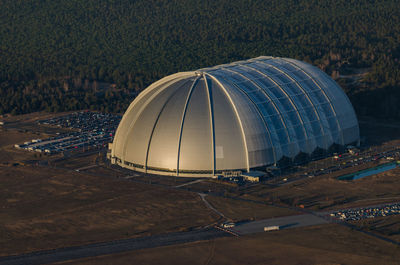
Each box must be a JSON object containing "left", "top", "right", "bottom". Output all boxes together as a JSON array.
[{"left": 0, "top": 166, "right": 219, "bottom": 255}]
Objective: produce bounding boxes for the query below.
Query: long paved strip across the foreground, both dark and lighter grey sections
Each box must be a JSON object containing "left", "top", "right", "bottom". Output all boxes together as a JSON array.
[{"left": 0, "top": 214, "right": 328, "bottom": 265}]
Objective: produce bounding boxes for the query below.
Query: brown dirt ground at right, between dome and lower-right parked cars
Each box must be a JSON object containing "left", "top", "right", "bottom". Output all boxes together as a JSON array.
[{"left": 241, "top": 168, "right": 400, "bottom": 210}]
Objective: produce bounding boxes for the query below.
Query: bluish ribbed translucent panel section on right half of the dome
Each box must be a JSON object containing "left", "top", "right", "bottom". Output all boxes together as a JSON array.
[{"left": 206, "top": 57, "right": 358, "bottom": 161}]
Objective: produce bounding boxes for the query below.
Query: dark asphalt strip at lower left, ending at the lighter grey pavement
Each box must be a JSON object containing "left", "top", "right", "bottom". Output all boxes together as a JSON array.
[{"left": 0, "top": 228, "right": 232, "bottom": 265}]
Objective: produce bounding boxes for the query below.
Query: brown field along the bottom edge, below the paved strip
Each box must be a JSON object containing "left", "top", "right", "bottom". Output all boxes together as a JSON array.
[{"left": 52, "top": 225, "right": 400, "bottom": 265}]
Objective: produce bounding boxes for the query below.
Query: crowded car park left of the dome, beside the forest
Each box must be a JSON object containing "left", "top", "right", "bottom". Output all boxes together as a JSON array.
[{"left": 14, "top": 111, "right": 121, "bottom": 154}]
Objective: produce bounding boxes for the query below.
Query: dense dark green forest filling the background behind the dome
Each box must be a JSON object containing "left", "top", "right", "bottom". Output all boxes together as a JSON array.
[{"left": 0, "top": 0, "right": 400, "bottom": 118}]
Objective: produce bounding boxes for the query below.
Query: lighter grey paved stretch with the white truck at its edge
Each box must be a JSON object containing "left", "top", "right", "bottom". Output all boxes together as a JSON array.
[{"left": 231, "top": 214, "right": 328, "bottom": 235}]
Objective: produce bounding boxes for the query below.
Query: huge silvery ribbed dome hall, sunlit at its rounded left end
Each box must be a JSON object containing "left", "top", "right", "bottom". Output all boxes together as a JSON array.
[{"left": 111, "top": 57, "right": 359, "bottom": 176}]
